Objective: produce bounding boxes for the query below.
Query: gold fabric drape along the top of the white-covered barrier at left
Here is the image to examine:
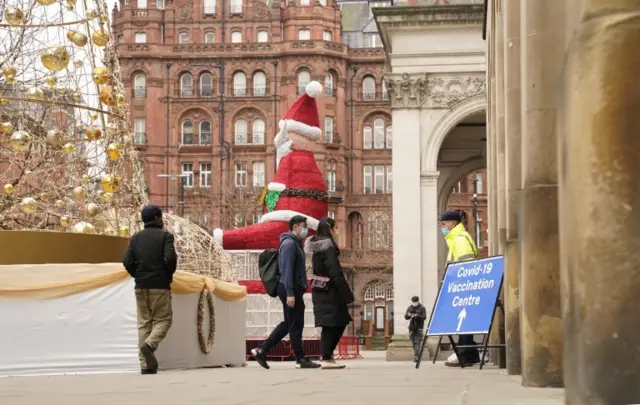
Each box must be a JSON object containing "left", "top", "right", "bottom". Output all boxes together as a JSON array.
[{"left": 0, "top": 263, "right": 247, "bottom": 301}]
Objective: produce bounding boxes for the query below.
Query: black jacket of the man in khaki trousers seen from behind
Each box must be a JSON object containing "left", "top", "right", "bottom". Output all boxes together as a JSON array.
[{"left": 122, "top": 222, "right": 178, "bottom": 290}]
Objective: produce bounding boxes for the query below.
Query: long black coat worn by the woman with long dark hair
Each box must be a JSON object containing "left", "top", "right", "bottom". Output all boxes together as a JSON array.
[{"left": 305, "top": 237, "right": 354, "bottom": 327}]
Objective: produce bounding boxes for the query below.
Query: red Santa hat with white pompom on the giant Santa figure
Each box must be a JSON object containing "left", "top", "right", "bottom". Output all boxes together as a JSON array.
[{"left": 273, "top": 81, "right": 322, "bottom": 148}]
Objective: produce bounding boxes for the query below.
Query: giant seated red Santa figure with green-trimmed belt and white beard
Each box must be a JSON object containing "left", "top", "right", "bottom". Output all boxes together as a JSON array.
[{"left": 213, "top": 81, "right": 328, "bottom": 250}]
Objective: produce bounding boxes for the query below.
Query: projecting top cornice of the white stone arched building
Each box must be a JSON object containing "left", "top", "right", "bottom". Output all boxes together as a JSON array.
[{"left": 372, "top": 4, "right": 484, "bottom": 54}]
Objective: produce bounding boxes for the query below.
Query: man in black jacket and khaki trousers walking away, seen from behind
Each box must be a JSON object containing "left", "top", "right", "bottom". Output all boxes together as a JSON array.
[{"left": 123, "top": 205, "right": 178, "bottom": 374}]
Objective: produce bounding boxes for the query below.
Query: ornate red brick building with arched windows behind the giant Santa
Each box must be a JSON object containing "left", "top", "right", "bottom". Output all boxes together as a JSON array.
[{"left": 113, "top": 0, "right": 486, "bottom": 340}]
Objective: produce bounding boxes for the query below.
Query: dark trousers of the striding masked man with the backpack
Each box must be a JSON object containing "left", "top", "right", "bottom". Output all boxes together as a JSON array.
[{"left": 260, "top": 284, "right": 305, "bottom": 360}]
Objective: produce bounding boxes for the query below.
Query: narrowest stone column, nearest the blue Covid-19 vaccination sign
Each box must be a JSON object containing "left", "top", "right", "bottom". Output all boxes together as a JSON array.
[{"left": 504, "top": 0, "right": 522, "bottom": 374}]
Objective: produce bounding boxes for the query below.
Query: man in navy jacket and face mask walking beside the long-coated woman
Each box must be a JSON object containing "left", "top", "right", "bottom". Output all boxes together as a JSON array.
[{"left": 251, "top": 215, "right": 320, "bottom": 369}]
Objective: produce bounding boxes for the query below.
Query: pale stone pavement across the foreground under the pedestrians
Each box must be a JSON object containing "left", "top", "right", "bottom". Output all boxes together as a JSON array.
[{"left": 0, "top": 352, "right": 564, "bottom": 405}]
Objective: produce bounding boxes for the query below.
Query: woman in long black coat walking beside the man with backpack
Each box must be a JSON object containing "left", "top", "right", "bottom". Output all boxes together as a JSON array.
[{"left": 305, "top": 218, "right": 354, "bottom": 368}]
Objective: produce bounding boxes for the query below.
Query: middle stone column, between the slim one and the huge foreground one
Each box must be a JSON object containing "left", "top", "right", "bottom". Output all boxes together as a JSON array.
[{"left": 520, "top": 0, "right": 564, "bottom": 387}]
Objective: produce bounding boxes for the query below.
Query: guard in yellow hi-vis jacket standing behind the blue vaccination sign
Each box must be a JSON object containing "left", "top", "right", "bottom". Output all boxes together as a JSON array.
[{"left": 440, "top": 211, "right": 480, "bottom": 367}]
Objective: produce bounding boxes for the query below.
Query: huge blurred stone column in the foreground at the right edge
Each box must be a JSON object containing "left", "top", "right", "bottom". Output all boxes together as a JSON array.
[{"left": 560, "top": 0, "right": 640, "bottom": 405}]
